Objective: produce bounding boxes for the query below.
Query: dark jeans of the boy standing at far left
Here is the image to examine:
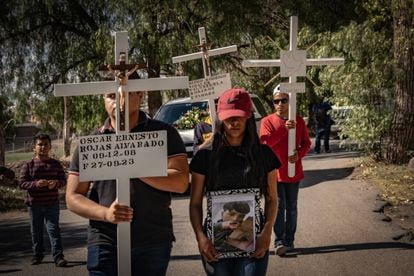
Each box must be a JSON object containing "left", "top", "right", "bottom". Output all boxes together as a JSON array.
[{"left": 27, "top": 203, "right": 63, "bottom": 261}]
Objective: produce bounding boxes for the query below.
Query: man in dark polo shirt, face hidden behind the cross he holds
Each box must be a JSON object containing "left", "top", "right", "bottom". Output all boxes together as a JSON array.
[{"left": 66, "top": 73, "right": 189, "bottom": 275}]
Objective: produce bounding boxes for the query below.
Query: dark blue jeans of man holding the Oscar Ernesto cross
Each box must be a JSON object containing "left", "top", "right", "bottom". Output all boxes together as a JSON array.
[{"left": 87, "top": 242, "right": 172, "bottom": 276}]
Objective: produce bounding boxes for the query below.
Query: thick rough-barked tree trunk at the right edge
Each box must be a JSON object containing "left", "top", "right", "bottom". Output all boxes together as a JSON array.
[{"left": 386, "top": 0, "right": 414, "bottom": 164}]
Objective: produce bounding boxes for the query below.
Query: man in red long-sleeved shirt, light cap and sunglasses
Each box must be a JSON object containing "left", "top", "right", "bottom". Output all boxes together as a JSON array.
[{"left": 260, "top": 85, "right": 311, "bottom": 256}]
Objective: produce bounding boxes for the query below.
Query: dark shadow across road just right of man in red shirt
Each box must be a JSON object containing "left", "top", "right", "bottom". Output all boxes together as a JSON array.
[{"left": 300, "top": 167, "right": 354, "bottom": 188}]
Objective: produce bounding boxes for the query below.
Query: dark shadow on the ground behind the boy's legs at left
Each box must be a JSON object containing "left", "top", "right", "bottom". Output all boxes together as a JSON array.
[{"left": 0, "top": 219, "right": 87, "bottom": 264}]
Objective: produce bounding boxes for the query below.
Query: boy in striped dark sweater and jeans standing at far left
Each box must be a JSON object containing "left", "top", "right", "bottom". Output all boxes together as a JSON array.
[{"left": 19, "top": 133, "right": 67, "bottom": 267}]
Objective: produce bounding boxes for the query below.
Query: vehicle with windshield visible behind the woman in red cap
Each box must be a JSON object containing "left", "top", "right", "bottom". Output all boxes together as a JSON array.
[{"left": 154, "top": 94, "right": 267, "bottom": 158}]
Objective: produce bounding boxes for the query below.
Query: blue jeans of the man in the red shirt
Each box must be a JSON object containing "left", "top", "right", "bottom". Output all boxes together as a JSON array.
[{"left": 273, "top": 182, "right": 299, "bottom": 246}]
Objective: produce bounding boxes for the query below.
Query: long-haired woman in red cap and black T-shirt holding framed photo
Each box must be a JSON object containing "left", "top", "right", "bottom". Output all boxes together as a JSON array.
[{"left": 190, "top": 88, "right": 280, "bottom": 275}]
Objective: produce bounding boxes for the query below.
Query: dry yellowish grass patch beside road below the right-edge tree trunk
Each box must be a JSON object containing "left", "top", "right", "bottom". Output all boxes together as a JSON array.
[{"left": 359, "top": 157, "right": 414, "bottom": 206}]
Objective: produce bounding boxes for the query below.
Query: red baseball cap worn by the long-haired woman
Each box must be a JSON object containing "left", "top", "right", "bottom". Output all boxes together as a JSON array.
[{"left": 217, "top": 88, "right": 253, "bottom": 121}]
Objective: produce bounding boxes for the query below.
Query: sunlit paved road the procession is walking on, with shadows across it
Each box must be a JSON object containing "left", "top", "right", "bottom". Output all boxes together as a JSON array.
[{"left": 0, "top": 142, "right": 414, "bottom": 276}]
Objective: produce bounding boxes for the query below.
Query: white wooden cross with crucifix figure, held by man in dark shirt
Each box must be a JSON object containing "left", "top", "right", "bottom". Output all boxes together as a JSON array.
[{"left": 54, "top": 32, "right": 188, "bottom": 275}]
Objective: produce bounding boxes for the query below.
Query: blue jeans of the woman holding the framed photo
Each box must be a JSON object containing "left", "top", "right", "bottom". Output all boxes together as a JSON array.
[{"left": 203, "top": 251, "right": 269, "bottom": 276}]
